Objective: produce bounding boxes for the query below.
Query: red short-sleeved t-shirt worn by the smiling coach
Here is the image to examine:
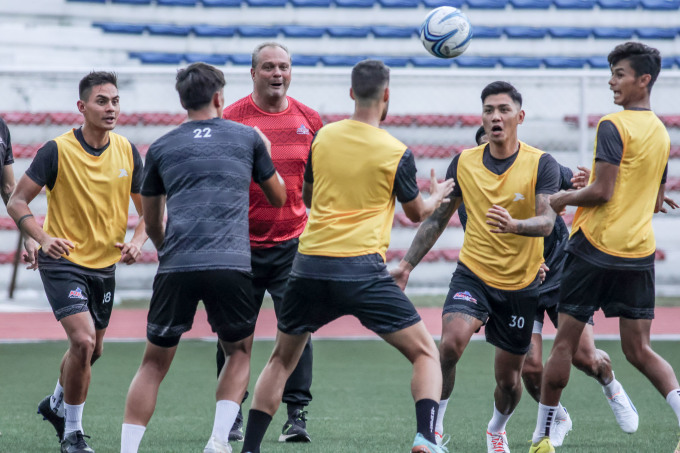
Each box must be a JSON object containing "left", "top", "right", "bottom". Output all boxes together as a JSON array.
[{"left": 222, "top": 95, "right": 323, "bottom": 248}]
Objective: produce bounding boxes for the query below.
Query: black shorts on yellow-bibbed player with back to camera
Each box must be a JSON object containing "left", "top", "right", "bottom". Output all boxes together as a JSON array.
[{"left": 278, "top": 275, "right": 420, "bottom": 335}]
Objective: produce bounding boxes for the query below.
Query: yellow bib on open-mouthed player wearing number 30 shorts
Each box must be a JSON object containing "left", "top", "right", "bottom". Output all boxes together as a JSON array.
[{"left": 457, "top": 142, "right": 543, "bottom": 291}]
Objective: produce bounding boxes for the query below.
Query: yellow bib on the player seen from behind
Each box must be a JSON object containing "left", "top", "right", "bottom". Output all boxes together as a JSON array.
[{"left": 298, "top": 120, "right": 406, "bottom": 259}]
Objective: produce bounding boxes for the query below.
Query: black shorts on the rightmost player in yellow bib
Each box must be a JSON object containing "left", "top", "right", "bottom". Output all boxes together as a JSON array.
[{"left": 558, "top": 253, "right": 654, "bottom": 322}]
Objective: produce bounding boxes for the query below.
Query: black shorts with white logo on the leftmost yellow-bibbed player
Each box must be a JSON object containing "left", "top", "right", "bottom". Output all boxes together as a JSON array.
[{"left": 40, "top": 269, "right": 116, "bottom": 330}]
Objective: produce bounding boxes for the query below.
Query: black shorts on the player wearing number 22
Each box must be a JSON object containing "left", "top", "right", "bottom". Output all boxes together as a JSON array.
[{"left": 146, "top": 269, "right": 258, "bottom": 348}]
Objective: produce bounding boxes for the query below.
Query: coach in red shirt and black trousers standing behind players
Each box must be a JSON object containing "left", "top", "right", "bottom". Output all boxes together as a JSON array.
[{"left": 217, "top": 42, "right": 323, "bottom": 442}]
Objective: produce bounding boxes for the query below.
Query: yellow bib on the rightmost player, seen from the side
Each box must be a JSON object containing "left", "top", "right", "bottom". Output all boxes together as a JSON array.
[{"left": 571, "top": 110, "right": 671, "bottom": 258}]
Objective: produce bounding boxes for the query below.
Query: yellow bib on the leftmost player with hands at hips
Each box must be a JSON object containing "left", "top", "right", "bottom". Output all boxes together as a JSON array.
[{"left": 43, "top": 131, "right": 134, "bottom": 269}]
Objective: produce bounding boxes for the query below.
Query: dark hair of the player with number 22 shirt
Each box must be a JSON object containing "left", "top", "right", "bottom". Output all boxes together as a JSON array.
[{"left": 175, "top": 62, "right": 226, "bottom": 110}]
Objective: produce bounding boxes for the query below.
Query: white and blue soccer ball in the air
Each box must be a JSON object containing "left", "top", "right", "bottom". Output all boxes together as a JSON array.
[{"left": 420, "top": 6, "right": 472, "bottom": 58}]
